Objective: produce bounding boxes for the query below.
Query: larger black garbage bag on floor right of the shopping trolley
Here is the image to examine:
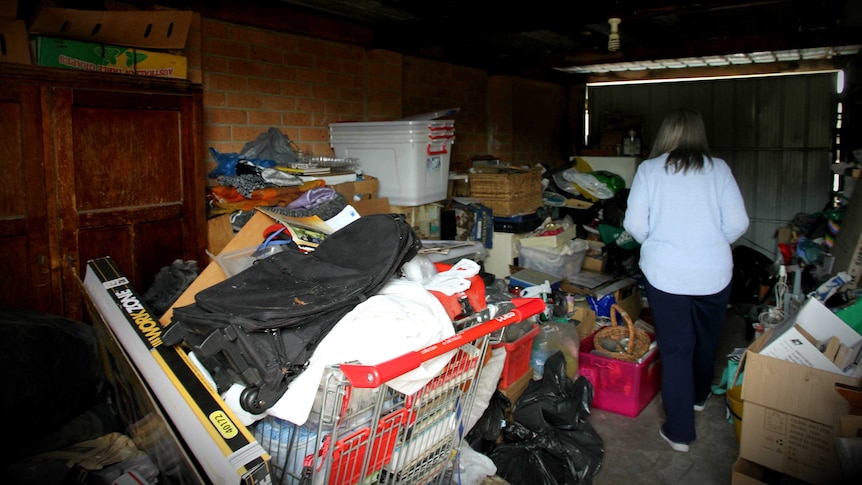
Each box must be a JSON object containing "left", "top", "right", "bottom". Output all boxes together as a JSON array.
[{"left": 487, "top": 352, "right": 604, "bottom": 485}]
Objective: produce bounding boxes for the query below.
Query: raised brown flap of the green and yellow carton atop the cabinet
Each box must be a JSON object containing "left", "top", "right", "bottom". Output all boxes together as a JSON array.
[{"left": 30, "top": 7, "right": 194, "bottom": 49}]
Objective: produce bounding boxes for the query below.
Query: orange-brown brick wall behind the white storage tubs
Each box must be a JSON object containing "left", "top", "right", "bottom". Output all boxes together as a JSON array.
[{"left": 201, "top": 19, "right": 566, "bottom": 179}]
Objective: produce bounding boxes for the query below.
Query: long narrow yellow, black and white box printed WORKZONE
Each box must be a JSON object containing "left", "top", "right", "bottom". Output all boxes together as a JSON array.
[{"left": 84, "top": 257, "right": 272, "bottom": 484}]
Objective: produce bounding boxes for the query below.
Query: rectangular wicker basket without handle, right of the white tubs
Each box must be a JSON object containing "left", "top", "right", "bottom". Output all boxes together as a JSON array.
[{"left": 470, "top": 167, "right": 542, "bottom": 217}]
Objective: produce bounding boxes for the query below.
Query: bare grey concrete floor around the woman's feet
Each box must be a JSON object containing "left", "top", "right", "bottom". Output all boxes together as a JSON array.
[{"left": 589, "top": 310, "right": 749, "bottom": 485}]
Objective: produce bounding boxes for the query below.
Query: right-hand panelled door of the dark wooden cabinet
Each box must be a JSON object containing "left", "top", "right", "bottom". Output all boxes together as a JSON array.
[{"left": 51, "top": 87, "right": 206, "bottom": 322}]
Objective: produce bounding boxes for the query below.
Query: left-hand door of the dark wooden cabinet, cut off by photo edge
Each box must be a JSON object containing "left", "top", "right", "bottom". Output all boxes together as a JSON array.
[{"left": 0, "top": 81, "right": 63, "bottom": 314}]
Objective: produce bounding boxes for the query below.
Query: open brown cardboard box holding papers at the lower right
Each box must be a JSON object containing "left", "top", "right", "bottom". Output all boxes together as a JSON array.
[{"left": 739, "top": 336, "right": 860, "bottom": 484}]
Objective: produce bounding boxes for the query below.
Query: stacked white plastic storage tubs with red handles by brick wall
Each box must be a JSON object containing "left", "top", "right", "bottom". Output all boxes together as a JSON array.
[{"left": 329, "top": 120, "right": 455, "bottom": 206}]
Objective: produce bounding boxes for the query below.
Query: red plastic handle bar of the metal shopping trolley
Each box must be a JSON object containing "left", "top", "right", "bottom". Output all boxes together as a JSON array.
[{"left": 338, "top": 298, "right": 545, "bottom": 388}]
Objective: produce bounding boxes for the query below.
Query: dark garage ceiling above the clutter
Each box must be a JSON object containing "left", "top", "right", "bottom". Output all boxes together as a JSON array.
[{"left": 88, "top": 0, "right": 862, "bottom": 78}]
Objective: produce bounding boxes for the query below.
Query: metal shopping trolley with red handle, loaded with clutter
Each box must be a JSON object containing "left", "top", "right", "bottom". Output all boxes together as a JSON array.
[{"left": 251, "top": 298, "right": 545, "bottom": 485}]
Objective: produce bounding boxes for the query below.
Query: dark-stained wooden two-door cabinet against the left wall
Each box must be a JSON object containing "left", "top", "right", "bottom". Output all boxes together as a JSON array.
[{"left": 0, "top": 64, "right": 206, "bottom": 319}]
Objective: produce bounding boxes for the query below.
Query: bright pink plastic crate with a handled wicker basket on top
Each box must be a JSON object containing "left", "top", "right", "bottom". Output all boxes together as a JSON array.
[{"left": 578, "top": 333, "right": 661, "bottom": 418}]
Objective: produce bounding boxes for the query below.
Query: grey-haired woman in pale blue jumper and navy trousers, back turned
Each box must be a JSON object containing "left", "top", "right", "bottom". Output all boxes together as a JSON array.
[{"left": 623, "top": 109, "right": 748, "bottom": 452}]
